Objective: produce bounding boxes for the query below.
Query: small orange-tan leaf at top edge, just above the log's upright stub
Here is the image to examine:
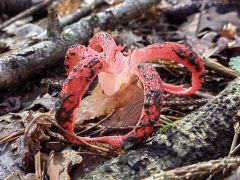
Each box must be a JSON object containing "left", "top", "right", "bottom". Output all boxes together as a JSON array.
[{"left": 57, "top": 0, "right": 81, "bottom": 17}]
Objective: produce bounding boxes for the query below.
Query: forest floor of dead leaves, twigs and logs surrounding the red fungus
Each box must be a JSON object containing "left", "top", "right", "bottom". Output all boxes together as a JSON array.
[{"left": 0, "top": 0, "right": 240, "bottom": 180}]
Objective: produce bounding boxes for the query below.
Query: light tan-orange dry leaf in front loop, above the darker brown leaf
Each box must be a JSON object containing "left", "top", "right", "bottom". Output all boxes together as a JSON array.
[{"left": 77, "top": 82, "right": 143, "bottom": 121}]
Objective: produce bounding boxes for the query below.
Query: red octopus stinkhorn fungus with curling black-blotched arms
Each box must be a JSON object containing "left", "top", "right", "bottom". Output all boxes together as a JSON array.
[{"left": 56, "top": 32, "right": 205, "bottom": 149}]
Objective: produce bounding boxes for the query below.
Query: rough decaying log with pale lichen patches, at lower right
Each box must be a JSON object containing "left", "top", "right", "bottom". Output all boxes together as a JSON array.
[{"left": 83, "top": 78, "right": 240, "bottom": 179}]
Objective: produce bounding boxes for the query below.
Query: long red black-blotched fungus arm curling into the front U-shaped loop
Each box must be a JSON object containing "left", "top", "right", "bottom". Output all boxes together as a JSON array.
[{"left": 56, "top": 62, "right": 162, "bottom": 149}]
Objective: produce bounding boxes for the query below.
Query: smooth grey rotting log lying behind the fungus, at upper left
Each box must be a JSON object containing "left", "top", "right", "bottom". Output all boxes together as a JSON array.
[{"left": 0, "top": 0, "right": 161, "bottom": 88}]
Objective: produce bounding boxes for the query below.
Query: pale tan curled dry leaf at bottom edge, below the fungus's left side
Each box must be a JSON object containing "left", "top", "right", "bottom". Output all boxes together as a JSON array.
[{"left": 47, "top": 149, "right": 82, "bottom": 180}]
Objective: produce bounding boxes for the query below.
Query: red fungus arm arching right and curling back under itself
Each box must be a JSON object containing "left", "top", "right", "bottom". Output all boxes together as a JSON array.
[{"left": 130, "top": 42, "right": 205, "bottom": 95}]
